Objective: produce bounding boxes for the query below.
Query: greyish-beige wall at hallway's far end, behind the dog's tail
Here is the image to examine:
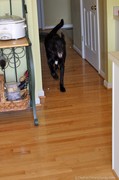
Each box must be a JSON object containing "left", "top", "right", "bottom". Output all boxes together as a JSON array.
[{"left": 37, "top": 0, "right": 72, "bottom": 29}]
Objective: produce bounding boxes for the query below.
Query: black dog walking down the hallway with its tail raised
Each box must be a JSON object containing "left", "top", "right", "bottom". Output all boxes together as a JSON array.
[{"left": 45, "top": 19, "right": 66, "bottom": 92}]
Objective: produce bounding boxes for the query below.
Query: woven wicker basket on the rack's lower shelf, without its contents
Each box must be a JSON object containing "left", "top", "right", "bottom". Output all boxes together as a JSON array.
[{"left": 0, "top": 75, "right": 30, "bottom": 112}]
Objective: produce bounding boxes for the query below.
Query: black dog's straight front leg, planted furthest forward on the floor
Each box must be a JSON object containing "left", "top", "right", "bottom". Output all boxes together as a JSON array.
[{"left": 60, "top": 64, "right": 66, "bottom": 92}]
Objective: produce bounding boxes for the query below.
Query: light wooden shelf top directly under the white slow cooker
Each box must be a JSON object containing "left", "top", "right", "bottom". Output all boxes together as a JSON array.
[{"left": 0, "top": 37, "right": 29, "bottom": 49}]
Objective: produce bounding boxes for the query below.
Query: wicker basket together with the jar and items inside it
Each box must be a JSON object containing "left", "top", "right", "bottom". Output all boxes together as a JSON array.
[{"left": 0, "top": 71, "right": 30, "bottom": 112}]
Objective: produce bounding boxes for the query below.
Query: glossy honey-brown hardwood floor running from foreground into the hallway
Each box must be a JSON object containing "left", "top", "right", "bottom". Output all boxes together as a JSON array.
[{"left": 0, "top": 32, "right": 117, "bottom": 180}]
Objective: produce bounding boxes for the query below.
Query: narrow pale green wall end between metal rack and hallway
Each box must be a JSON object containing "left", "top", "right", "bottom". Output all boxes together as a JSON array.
[{"left": 26, "top": 0, "right": 44, "bottom": 102}]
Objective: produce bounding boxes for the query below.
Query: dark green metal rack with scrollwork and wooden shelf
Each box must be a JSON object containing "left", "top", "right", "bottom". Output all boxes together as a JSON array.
[{"left": 0, "top": 0, "right": 39, "bottom": 126}]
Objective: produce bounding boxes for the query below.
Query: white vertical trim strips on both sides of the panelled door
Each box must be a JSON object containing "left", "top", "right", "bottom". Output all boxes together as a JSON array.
[{"left": 80, "top": 0, "right": 101, "bottom": 73}]
